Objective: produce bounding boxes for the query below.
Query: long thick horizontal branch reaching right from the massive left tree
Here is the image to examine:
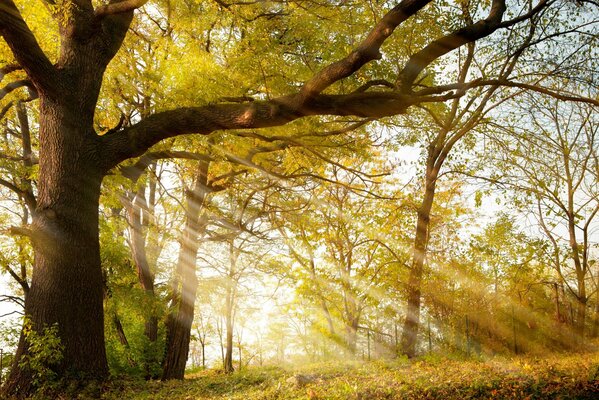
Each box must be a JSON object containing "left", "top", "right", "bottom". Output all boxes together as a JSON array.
[{"left": 102, "top": 92, "right": 426, "bottom": 169}]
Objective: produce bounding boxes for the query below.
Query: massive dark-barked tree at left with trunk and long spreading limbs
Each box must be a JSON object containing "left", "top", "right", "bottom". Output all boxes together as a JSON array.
[{"left": 0, "top": 0, "right": 597, "bottom": 395}]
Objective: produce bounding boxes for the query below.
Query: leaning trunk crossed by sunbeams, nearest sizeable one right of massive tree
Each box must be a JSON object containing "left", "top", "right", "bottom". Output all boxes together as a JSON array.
[{"left": 162, "top": 161, "right": 210, "bottom": 380}]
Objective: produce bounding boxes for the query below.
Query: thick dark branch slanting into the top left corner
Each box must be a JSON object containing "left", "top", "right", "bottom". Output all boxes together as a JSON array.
[{"left": 0, "top": 0, "right": 56, "bottom": 89}]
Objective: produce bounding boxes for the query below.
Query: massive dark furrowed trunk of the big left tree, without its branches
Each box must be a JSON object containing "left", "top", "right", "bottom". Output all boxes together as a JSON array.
[{"left": 5, "top": 97, "right": 108, "bottom": 395}]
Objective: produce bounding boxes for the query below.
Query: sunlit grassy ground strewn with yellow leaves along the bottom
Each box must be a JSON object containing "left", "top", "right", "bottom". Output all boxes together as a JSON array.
[{"left": 99, "top": 353, "right": 599, "bottom": 400}]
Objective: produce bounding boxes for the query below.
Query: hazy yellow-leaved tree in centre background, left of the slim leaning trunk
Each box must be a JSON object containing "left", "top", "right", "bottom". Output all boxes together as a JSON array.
[{"left": 271, "top": 167, "right": 398, "bottom": 356}]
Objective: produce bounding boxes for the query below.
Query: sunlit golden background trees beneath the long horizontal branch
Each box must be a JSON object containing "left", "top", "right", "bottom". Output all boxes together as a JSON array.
[{"left": 3, "top": 96, "right": 599, "bottom": 379}]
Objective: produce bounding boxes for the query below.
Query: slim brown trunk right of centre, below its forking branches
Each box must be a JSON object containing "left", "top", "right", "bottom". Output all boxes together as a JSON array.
[{"left": 401, "top": 161, "right": 438, "bottom": 358}]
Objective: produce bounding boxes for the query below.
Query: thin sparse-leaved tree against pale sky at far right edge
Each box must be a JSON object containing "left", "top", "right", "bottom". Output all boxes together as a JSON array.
[{"left": 494, "top": 96, "right": 599, "bottom": 339}]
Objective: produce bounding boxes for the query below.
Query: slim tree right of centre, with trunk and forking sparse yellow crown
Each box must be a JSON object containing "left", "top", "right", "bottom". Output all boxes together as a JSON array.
[{"left": 401, "top": 3, "right": 592, "bottom": 357}]
